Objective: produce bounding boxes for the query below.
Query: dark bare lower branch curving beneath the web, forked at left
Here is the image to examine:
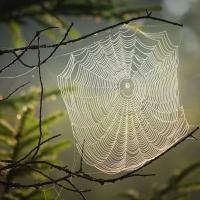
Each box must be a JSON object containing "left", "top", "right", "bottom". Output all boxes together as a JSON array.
[{"left": 0, "top": 127, "right": 199, "bottom": 199}]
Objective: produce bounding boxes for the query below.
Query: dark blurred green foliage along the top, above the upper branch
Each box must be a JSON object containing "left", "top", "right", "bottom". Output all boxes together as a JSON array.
[{"left": 0, "top": 0, "right": 161, "bottom": 47}]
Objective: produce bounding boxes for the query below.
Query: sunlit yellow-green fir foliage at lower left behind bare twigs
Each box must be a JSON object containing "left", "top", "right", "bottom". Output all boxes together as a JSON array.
[{"left": 0, "top": 88, "right": 71, "bottom": 200}]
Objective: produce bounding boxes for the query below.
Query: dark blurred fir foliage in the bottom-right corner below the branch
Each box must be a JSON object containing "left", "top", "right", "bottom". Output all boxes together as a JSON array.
[{"left": 119, "top": 162, "right": 200, "bottom": 200}]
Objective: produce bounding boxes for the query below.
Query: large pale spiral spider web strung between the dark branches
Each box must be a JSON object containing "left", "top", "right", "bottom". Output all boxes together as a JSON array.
[{"left": 57, "top": 26, "right": 189, "bottom": 173}]
